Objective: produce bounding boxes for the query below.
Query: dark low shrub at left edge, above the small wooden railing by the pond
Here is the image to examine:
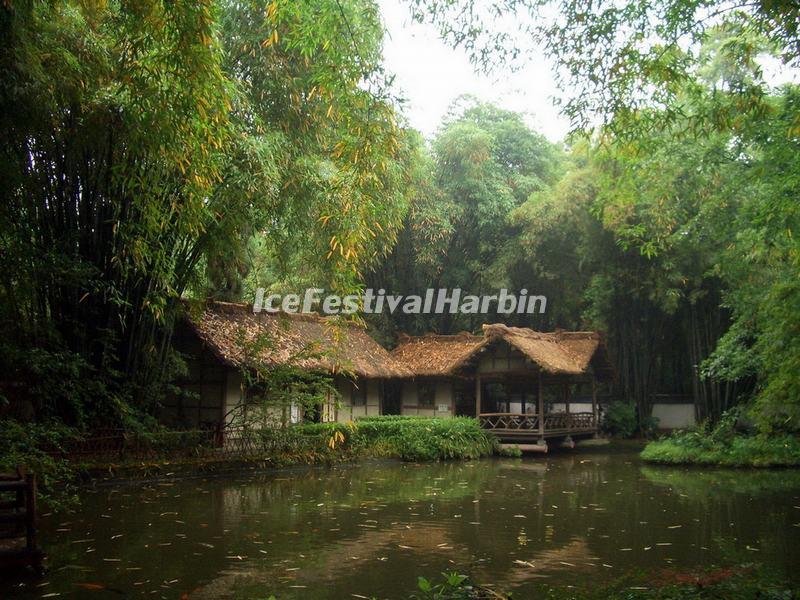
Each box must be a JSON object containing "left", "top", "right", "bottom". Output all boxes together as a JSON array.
[{"left": 0, "top": 419, "right": 78, "bottom": 509}]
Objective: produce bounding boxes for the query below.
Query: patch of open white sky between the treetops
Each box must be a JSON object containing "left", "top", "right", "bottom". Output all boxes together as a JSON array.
[{"left": 379, "top": 0, "right": 569, "bottom": 142}]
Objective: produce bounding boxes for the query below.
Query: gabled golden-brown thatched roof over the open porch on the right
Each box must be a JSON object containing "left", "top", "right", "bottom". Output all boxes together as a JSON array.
[{"left": 392, "top": 324, "right": 613, "bottom": 379}]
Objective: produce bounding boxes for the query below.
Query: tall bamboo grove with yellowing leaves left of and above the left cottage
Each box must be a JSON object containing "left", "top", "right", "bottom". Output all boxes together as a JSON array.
[{"left": 0, "top": 0, "right": 414, "bottom": 427}]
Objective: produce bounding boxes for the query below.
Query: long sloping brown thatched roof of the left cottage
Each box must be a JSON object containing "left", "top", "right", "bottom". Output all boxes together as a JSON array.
[{"left": 188, "top": 302, "right": 410, "bottom": 378}]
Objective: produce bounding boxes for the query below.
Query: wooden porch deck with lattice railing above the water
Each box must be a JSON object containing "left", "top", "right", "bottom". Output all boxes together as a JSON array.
[{"left": 478, "top": 412, "right": 597, "bottom": 444}]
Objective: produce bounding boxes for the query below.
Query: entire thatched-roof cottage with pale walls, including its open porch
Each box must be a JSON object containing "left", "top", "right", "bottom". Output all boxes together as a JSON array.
[{"left": 162, "top": 302, "right": 612, "bottom": 443}]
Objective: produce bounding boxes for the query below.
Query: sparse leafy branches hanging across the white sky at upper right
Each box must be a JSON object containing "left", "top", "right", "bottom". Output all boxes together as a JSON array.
[{"left": 409, "top": 0, "right": 800, "bottom": 137}]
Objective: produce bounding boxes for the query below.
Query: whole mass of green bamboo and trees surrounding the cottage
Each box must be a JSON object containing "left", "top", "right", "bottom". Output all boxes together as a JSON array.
[{"left": 0, "top": 0, "right": 800, "bottom": 452}]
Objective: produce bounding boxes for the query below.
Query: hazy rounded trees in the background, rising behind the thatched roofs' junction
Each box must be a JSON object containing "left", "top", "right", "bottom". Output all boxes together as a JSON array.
[{"left": 367, "top": 97, "right": 562, "bottom": 333}]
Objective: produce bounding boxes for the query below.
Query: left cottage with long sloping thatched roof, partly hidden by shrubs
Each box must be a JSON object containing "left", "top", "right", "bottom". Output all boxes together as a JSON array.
[{"left": 160, "top": 302, "right": 411, "bottom": 428}]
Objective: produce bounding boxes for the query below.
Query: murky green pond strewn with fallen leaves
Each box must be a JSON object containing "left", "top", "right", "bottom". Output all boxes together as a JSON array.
[{"left": 0, "top": 446, "right": 800, "bottom": 600}]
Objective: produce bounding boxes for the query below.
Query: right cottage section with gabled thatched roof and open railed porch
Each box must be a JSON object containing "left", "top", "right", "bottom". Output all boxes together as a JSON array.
[{"left": 392, "top": 324, "right": 613, "bottom": 442}]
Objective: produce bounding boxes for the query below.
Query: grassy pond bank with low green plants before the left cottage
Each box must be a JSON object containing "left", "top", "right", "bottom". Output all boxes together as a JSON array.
[{"left": 14, "top": 416, "right": 506, "bottom": 496}]
